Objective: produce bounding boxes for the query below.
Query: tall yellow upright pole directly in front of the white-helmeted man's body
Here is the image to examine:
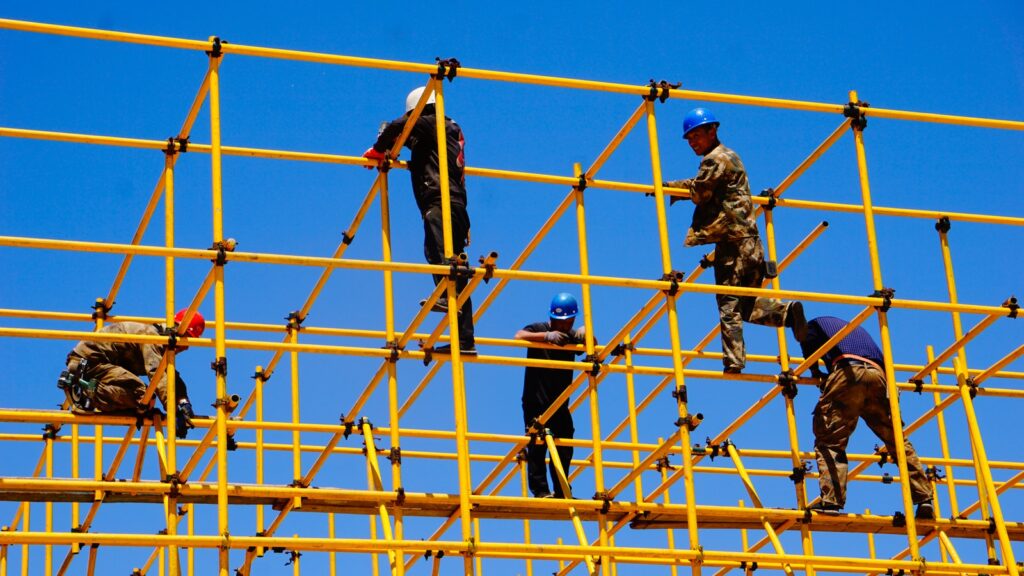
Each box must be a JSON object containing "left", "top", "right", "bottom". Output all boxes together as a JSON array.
[{"left": 433, "top": 79, "right": 475, "bottom": 574}]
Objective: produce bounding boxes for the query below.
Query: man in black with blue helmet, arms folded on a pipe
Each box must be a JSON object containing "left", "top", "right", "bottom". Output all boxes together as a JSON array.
[{"left": 515, "top": 292, "right": 585, "bottom": 498}]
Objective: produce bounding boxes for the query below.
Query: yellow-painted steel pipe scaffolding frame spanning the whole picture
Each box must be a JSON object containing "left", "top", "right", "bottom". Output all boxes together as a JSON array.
[{"left": 0, "top": 19, "right": 1024, "bottom": 576}]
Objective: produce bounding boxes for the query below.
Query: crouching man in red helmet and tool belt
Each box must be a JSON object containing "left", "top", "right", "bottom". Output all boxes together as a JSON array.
[{"left": 57, "top": 310, "right": 206, "bottom": 438}]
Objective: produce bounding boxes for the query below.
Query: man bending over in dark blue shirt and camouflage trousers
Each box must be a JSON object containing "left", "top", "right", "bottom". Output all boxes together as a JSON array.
[{"left": 800, "top": 316, "right": 935, "bottom": 520}]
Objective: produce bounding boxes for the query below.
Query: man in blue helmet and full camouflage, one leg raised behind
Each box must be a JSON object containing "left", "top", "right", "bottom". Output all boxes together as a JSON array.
[{"left": 665, "top": 108, "right": 807, "bottom": 374}]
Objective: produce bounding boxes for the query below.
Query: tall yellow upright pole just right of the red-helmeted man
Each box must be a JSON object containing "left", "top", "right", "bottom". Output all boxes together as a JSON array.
[{"left": 204, "top": 38, "right": 230, "bottom": 576}]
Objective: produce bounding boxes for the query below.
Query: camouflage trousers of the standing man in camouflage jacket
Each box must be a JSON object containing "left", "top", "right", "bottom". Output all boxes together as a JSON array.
[{"left": 715, "top": 236, "right": 786, "bottom": 369}]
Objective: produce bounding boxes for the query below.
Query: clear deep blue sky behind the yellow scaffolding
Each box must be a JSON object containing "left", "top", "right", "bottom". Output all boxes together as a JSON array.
[{"left": 0, "top": 1, "right": 1024, "bottom": 574}]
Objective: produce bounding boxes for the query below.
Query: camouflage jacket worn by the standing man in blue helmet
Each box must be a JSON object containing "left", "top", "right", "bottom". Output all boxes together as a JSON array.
[{"left": 668, "top": 143, "right": 758, "bottom": 246}]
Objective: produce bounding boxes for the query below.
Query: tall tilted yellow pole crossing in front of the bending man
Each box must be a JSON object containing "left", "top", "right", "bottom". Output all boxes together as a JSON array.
[{"left": 850, "top": 90, "right": 922, "bottom": 561}]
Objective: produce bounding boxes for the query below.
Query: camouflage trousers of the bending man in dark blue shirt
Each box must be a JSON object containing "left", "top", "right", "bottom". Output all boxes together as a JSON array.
[{"left": 814, "top": 364, "right": 932, "bottom": 507}]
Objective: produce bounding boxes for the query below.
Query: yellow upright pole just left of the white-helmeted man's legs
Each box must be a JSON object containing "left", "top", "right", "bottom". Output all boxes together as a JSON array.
[{"left": 379, "top": 154, "right": 403, "bottom": 576}]
